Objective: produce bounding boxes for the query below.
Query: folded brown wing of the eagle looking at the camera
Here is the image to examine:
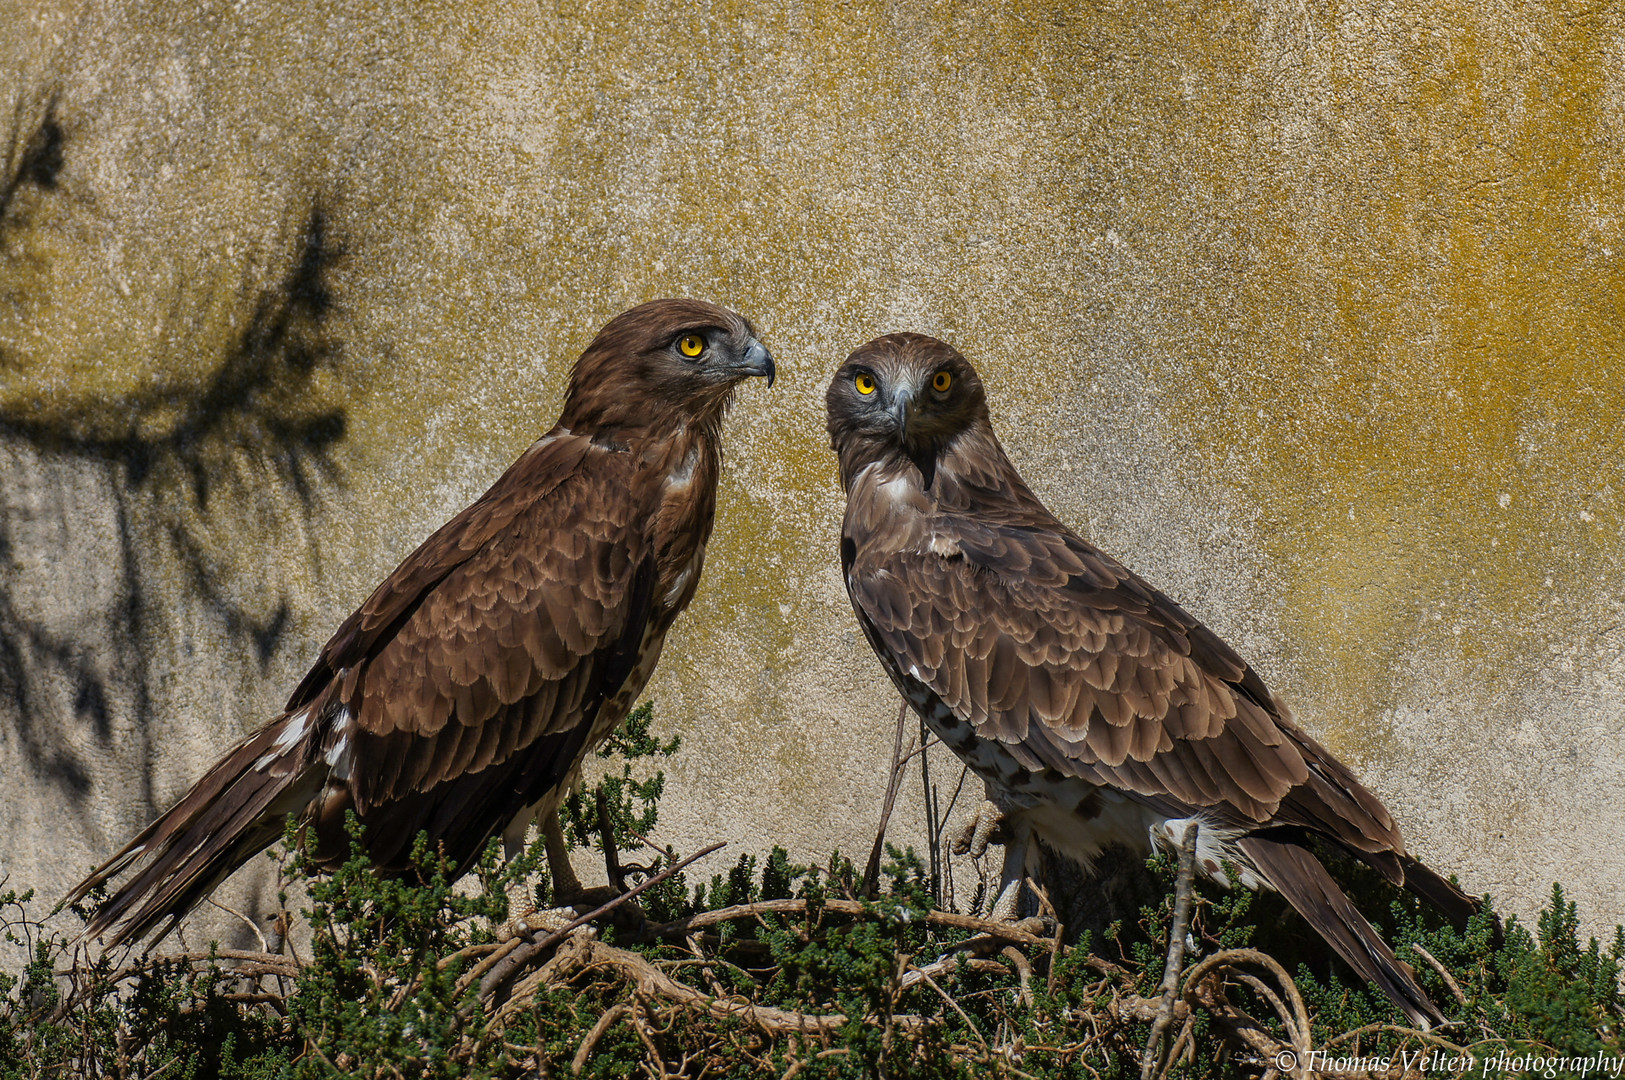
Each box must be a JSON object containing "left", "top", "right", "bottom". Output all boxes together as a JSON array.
[{"left": 847, "top": 513, "right": 1402, "bottom": 853}]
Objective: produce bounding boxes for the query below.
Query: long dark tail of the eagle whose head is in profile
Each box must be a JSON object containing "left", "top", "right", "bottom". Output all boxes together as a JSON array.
[{"left": 63, "top": 708, "right": 325, "bottom": 948}]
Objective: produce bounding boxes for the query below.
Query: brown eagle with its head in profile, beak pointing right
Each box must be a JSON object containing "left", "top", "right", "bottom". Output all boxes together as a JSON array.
[{"left": 68, "top": 300, "right": 774, "bottom": 947}]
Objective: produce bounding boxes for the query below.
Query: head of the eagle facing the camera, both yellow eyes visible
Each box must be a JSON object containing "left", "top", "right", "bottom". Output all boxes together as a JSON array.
[{"left": 824, "top": 333, "right": 991, "bottom": 489}]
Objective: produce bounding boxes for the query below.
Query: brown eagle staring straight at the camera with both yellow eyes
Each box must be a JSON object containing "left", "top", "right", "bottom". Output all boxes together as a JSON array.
[{"left": 826, "top": 333, "right": 1477, "bottom": 1025}]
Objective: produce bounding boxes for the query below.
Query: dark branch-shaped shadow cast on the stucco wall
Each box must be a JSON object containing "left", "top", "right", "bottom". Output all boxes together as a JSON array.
[{"left": 0, "top": 101, "right": 346, "bottom": 817}]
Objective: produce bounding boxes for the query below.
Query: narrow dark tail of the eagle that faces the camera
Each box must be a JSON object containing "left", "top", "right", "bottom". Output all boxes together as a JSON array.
[{"left": 1237, "top": 835, "right": 1445, "bottom": 1028}]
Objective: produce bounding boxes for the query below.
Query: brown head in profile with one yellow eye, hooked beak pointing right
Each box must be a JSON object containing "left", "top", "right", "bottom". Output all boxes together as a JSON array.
[{"left": 559, "top": 299, "right": 777, "bottom": 434}]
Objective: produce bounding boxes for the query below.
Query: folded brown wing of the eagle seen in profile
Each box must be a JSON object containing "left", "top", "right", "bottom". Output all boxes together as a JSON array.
[{"left": 323, "top": 455, "right": 653, "bottom": 866}]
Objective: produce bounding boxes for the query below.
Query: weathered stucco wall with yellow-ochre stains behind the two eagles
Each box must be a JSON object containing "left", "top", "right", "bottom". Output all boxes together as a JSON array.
[{"left": 0, "top": 0, "right": 1625, "bottom": 926}]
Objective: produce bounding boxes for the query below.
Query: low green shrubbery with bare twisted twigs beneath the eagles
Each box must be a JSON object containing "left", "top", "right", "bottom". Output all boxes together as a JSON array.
[{"left": 0, "top": 705, "right": 1625, "bottom": 1080}]
